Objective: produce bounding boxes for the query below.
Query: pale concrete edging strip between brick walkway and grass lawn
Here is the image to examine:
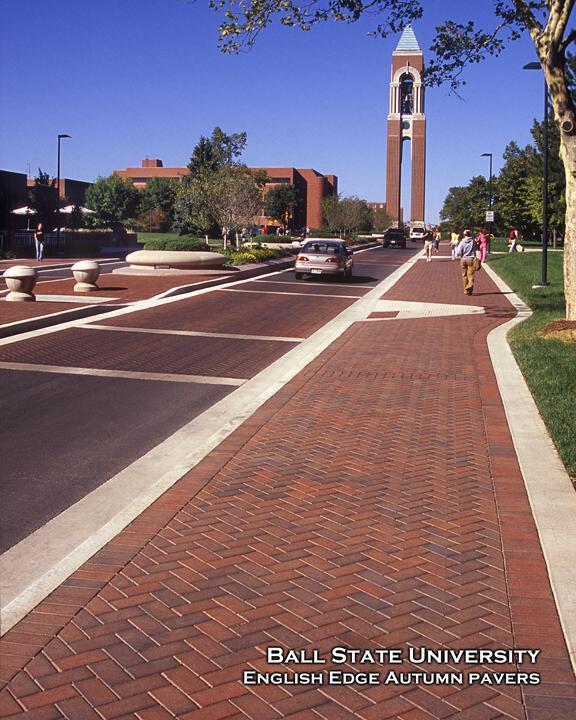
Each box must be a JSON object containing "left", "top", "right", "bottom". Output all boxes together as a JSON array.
[{"left": 483, "top": 264, "right": 576, "bottom": 672}]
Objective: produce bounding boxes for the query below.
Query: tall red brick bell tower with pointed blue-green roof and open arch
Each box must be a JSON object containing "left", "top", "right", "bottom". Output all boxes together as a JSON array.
[{"left": 386, "top": 25, "right": 426, "bottom": 225}]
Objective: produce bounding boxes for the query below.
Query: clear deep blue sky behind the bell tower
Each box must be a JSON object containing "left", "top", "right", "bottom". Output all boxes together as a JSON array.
[{"left": 0, "top": 0, "right": 564, "bottom": 222}]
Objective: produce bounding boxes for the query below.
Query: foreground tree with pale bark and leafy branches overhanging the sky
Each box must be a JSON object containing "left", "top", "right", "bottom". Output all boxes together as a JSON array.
[{"left": 209, "top": 0, "right": 576, "bottom": 320}]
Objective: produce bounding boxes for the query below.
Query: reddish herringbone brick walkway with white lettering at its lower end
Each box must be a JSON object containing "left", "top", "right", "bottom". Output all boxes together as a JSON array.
[{"left": 0, "top": 250, "right": 576, "bottom": 720}]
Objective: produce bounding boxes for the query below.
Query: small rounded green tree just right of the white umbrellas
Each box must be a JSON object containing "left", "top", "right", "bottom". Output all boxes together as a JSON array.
[{"left": 86, "top": 175, "right": 140, "bottom": 229}]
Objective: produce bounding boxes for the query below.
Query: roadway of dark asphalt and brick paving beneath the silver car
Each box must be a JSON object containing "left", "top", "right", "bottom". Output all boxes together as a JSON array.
[{"left": 0, "top": 246, "right": 420, "bottom": 551}]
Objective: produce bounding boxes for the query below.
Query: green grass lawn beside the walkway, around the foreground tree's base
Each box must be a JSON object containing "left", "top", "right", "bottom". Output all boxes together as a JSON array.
[{"left": 489, "top": 252, "right": 576, "bottom": 481}]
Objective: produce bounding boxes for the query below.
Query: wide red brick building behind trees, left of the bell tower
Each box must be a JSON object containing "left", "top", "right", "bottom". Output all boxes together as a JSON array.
[{"left": 114, "top": 158, "right": 338, "bottom": 229}]
